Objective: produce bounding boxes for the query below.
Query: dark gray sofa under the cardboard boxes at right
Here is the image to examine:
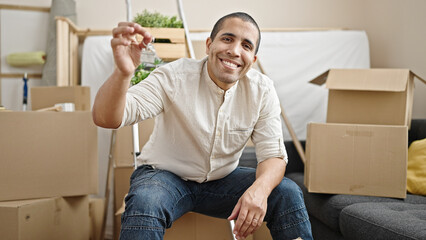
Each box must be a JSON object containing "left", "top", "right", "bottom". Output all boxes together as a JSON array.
[{"left": 240, "top": 119, "right": 426, "bottom": 240}]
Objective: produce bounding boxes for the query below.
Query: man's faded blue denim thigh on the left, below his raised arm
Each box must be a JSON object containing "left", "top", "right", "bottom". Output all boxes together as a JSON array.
[{"left": 123, "top": 165, "right": 193, "bottom": 228}]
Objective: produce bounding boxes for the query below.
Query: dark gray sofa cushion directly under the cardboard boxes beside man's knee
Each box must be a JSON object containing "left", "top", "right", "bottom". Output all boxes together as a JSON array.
[{"left": 286, "top": 173, "right": 426, "bottom": 231}]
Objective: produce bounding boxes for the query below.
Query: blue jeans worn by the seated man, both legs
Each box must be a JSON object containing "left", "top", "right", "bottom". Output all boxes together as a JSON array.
[{"left": 120, "top": 165, "right": 312, "bottom": 240}]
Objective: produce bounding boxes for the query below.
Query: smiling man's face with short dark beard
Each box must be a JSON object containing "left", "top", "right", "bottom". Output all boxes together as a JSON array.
[{"left": 206, "top": 18, "right": 259, "bottom": 90}]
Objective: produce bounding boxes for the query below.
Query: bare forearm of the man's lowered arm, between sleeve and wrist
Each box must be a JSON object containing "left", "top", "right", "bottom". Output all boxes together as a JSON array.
[{"left": 253, "top": 158, "right": 286, "bottom": 196}]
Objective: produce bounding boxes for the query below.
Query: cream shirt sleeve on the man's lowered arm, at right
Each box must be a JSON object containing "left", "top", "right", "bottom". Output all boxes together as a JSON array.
[{"left": 252, "top": 84, "right": 288, "bottom": 163}]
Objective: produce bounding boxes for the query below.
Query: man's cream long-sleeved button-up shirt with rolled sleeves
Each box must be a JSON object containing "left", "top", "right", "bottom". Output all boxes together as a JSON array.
[{"left": 121, "top": 58, "right": 287, "bottom": 182}]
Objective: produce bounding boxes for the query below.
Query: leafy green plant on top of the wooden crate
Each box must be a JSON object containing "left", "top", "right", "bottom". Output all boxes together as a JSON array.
[{"left": 133, "top": 9, "right": 183, "bottom": 28}]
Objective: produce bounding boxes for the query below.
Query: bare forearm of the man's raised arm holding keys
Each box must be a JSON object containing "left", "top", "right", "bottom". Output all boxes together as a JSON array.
[{"left": 92, "top": 69, "right": 131, "bottom": 128}]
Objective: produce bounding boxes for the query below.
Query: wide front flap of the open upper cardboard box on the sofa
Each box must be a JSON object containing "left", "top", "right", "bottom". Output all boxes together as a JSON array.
[{"left": 326, "top": 69, "right": 410, "bottom": 92}]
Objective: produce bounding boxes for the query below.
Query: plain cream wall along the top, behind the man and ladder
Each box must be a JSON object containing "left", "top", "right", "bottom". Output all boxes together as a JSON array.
[{"left": 4, "top": 0, "right": 426, "bottom": 118}]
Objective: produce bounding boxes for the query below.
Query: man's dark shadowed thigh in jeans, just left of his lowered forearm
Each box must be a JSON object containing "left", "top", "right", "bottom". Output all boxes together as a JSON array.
[{"left": 193, "top": 167, "right": 256, "bottom": 218}]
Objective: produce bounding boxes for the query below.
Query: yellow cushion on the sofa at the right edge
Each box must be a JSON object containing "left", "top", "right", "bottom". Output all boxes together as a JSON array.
[{"left": 407, "top": 138, "right": 426, "bottom": 195}]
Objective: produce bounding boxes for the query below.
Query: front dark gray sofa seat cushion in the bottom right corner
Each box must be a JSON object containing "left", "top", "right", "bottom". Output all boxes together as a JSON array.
[{"left": 340, "top": 202, "right": 426, "bottom": 239}]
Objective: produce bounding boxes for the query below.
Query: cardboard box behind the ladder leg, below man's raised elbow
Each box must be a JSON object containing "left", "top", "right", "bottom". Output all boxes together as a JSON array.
[{"left": 112, "top": 119, "right": 154, "bottom": 167}]
